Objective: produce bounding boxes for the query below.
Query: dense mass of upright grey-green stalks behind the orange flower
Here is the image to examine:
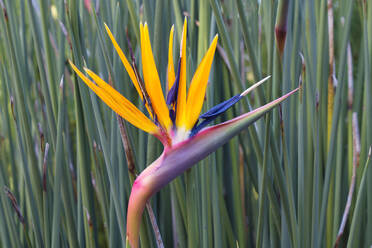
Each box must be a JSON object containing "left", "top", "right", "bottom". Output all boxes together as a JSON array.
[{"left": 0, "top": 0, "right": 372, "bottom": 247}]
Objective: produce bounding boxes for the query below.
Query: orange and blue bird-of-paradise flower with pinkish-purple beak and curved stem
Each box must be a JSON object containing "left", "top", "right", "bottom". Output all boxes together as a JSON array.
[{"left": 70, "top": 19, "right": 297, "bottom": 248}]
